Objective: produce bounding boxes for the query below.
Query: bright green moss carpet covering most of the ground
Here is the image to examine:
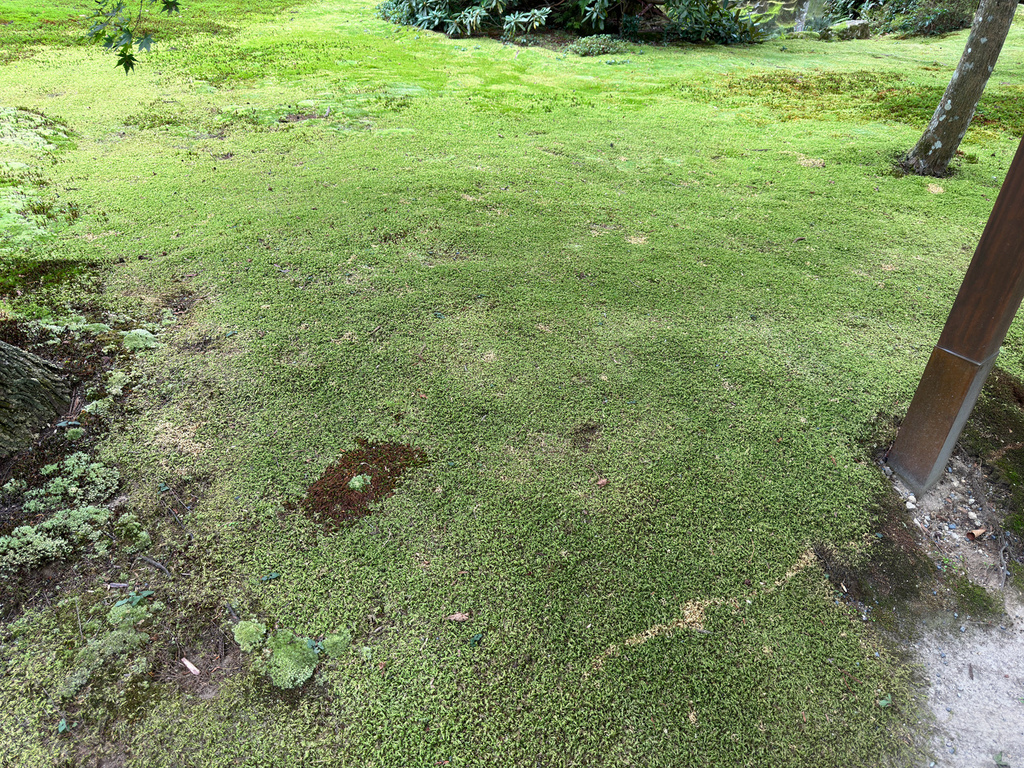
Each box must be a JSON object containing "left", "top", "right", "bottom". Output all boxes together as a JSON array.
[{"left": 0, "top": 0, "right": 1024, "bottom": 767}]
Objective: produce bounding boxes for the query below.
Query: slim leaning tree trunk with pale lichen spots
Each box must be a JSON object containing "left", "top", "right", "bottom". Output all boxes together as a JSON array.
[{"left": 900, "top": 0, "right": 1018, "bottom": 176}]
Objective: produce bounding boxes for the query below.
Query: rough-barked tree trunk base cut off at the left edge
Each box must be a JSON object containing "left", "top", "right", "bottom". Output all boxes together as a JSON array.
[{"left": 0, "top": 341, "right": 70, "bottom": 459}]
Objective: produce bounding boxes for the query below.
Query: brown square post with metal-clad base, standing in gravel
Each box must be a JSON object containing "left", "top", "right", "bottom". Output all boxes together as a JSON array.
[{"left": 889, "top": 140, "right": 1024, "bottom": 493}]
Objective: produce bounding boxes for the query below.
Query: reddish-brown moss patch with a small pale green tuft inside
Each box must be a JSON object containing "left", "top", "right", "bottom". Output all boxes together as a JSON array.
[{"left": 298, "top": 439, "right": 427, "bottom": 528}]
